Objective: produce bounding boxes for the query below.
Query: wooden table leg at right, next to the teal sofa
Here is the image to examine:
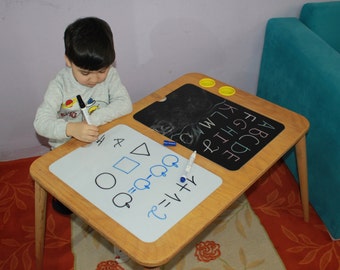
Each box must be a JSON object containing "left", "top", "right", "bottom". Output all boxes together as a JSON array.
[{"left": 295, "top": 136, "right": 309, "bottom": 222}]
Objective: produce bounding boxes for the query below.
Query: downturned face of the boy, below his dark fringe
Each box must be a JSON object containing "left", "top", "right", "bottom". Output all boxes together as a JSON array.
[{"left": 65, "top": 56, "right": 110, "bottom": 87}]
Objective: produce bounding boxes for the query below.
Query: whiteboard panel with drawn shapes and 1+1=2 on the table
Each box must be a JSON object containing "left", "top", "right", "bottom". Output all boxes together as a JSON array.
[{"left": 49, "top": 125, "right": 222, "bottom": 242}]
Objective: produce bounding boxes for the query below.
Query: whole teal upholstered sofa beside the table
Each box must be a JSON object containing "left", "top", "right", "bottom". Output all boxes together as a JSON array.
[{"left": 257, "top": 1, "right": 340, "bottom": 239}]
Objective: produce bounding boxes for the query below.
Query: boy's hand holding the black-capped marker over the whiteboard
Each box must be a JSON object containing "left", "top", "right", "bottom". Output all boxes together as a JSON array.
[{"left": 66, "top": 122, "right": 99, "bottom": 142}]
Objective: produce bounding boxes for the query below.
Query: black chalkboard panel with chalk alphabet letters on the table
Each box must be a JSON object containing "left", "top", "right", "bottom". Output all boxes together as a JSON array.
[{"left": 134, "top": 84, "right": 284, "bottom": 170}]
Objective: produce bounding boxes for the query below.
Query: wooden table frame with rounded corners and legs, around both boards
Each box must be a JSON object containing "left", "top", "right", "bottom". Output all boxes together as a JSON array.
[{"left": 30, "top": 73, "right": 309, "bottom": 269}]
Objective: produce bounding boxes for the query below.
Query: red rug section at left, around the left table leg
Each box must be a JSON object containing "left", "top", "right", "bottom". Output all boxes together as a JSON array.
[{"left": 0, "top": 158, "right": 74, "bottom": 270}]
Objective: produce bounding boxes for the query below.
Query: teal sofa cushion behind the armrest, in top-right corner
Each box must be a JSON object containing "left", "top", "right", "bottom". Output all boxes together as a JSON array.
[{"left": 300, "top": 1, "right": 340, "bottom": 52}]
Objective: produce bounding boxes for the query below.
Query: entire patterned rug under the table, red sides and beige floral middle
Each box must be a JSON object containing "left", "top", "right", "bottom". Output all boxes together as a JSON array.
[{"left": 0, "top": 158, "right": 340, "bottom": 270}]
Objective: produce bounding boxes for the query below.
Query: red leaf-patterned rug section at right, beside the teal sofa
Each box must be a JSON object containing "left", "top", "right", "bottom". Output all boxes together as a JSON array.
[{"left": 247, "top": 161, "right": 340, "bottom": 270}]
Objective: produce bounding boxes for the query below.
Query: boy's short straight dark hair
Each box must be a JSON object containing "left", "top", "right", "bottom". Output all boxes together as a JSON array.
[{"left": 64, "top": 17, "right": 116, "bottom": 70}]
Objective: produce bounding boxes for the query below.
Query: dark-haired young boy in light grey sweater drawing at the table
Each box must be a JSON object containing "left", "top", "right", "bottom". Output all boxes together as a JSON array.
[{"left": 34, "top": 17, "right": 132, "bottom": 214}]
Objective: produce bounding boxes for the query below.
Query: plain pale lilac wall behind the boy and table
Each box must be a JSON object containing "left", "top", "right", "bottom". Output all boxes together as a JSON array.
[{"left": 0, "top": 0, "right": 330, "bottom": 160}]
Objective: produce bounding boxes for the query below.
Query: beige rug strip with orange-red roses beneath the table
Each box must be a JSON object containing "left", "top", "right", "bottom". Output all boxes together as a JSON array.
[{"left": 72, "top": 196, "right": 285, "bottom": 270}]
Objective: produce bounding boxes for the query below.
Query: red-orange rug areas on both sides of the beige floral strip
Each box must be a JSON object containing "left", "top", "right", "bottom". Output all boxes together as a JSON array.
[{"left": 0, "top": 157, "right": 340, "bottom": 270}]
